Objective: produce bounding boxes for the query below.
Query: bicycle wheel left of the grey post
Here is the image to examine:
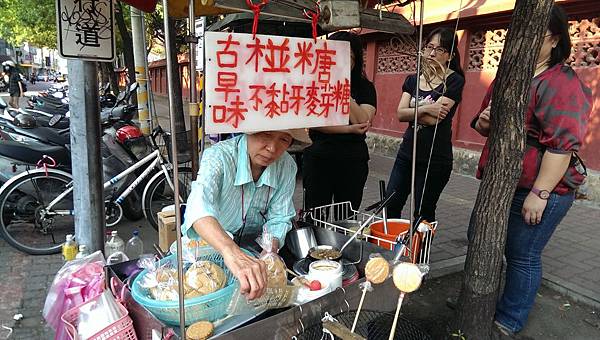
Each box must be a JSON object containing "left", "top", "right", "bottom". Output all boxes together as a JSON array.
[{"left": 0, "top": 170, "right": 75, "bottom": 255}]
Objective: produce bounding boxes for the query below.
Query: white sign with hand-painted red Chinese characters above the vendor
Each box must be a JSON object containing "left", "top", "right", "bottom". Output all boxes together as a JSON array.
[{"left": 205, "top": 32, "right": 350, "bottom": 133}]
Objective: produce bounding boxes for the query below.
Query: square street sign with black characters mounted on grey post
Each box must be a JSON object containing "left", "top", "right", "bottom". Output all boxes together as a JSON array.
[{"left": 56, "top": 0, "right": 115, "bottom": 61}]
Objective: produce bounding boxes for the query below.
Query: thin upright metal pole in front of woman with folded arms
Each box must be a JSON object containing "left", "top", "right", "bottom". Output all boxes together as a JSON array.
[{"left": 408, "top": 0, "right": 425, "bottom": 262}]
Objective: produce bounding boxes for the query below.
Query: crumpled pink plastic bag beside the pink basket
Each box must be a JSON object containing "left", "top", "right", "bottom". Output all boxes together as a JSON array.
[{"left": 42, "top": 251, "right": 105, "bottom": 340}]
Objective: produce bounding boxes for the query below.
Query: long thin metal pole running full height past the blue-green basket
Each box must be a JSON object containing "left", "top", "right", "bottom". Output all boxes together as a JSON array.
[{"left": 163, "top": 0, "right": 185, "bottom": 337}]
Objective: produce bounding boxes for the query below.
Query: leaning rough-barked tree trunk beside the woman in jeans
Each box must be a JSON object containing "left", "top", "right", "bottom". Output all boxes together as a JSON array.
[{"left": 456, "top": 0, "right": 554, "bottom": 339}]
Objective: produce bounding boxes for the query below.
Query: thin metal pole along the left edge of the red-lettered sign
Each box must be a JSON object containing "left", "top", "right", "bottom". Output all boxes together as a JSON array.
[{"left": 188, "top": 0, "right": 199, "bottom": 175}]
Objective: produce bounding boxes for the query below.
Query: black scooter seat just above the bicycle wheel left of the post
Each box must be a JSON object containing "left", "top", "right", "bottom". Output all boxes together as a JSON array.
[{"left": 0, "top": 141, "right": 71, "bottom": 167}]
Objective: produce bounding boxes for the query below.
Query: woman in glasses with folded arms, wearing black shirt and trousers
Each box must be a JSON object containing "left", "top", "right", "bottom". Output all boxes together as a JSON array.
[{"left": 387, "top": 28, "right": 465, "bottom": 222}]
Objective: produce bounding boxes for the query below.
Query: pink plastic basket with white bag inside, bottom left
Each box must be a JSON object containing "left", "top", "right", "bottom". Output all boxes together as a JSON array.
[{"left": 61, "top": 283, "right": 137, "bottom": 340}]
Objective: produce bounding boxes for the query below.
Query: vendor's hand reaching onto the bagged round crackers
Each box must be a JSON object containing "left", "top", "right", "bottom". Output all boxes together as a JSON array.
[{"left": 222, "top": 245, "right": 267, "bottom": 300}]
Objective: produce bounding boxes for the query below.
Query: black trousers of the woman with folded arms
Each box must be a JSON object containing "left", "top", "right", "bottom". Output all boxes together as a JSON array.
[{"left": 386, "top": 157, "right": 452, "bottom": 222}]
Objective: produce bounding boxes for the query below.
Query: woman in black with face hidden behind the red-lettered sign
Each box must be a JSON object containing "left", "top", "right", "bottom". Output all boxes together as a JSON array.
[{"left": 303, "top": 32, "right": 377, "bottom": 209}]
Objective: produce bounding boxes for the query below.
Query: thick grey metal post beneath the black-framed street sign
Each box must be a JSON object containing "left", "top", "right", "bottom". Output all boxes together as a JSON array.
[{"left": 68, "top": 60, "right": 105, "bottom": 252}]
